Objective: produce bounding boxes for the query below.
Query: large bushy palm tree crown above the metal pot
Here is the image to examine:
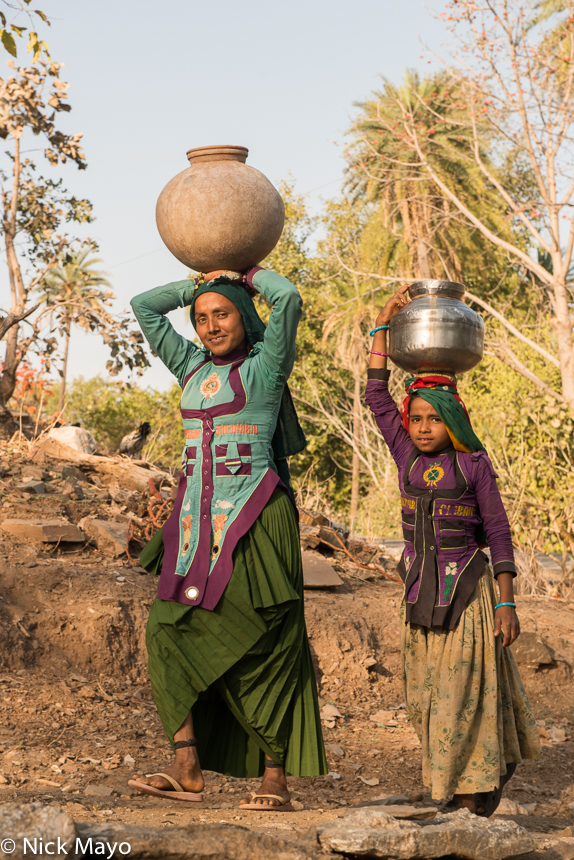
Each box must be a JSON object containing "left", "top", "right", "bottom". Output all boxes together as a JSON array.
[{"left": 347, "top": 70, "right": 529, "bottom": 287}]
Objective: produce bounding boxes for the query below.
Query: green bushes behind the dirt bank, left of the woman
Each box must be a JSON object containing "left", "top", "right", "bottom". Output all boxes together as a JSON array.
[{"left": 60, "top": 376, "right": 183, "bottom": 468}]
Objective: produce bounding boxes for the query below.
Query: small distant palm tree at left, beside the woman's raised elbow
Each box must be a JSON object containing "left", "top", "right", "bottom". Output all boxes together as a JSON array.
[{"left": 38, "top": 249, "right": 115, "bottom": 412}]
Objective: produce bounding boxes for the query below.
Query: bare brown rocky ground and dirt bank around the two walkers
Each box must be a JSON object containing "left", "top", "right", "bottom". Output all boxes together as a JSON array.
[{"left": 0, "top": 440, "right": 574, "bottom": 858}]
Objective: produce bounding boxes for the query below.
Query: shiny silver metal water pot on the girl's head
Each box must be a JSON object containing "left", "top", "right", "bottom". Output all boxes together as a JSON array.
[{"left": 389, "top": 281, "right": 484, "bottom": 374}]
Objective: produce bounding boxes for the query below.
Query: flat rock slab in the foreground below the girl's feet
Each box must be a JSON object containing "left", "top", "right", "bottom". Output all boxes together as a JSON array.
[{"left": 317, "top": 809, "right": 535, "bottom": 860}]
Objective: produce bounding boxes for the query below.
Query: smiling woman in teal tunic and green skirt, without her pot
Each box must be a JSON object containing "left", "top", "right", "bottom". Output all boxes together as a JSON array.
[{"left": 130, "top": 267, "right": 327, "bottom": 810}]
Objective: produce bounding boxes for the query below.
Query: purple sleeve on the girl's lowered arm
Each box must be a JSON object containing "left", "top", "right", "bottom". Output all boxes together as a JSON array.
[{"left": 471, "top": 452, "right": 516, "bottom": 576}]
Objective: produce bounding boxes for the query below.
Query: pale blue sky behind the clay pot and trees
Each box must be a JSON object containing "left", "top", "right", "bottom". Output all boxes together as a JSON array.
[{"left": 0, "top": 0, "right": 446, "bottom": 388}]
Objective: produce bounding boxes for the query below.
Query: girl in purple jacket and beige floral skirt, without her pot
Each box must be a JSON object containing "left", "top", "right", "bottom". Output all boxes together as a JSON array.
[{"left": 366, "top": 287, "right": 541, "bottom": 816}]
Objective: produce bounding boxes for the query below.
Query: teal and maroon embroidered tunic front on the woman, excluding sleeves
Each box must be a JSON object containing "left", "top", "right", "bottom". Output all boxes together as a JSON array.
[{"left": 158, "top": 347, "right": 283, "bottom": 609}]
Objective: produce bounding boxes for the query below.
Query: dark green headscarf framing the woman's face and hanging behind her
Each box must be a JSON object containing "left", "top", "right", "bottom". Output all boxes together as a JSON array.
[{"left": 189, "top": 275, "right": 307, "bottom": 489}]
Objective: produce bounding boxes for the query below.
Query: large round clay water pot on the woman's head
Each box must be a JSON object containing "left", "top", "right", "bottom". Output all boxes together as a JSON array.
[{"left": 156, "top": 146, "right": 285, "bottom": 272}]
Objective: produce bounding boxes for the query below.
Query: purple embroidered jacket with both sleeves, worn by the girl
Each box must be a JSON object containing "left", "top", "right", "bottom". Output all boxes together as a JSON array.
[{"left": 365, "top": 371, "right": 516, "bottom": 630}]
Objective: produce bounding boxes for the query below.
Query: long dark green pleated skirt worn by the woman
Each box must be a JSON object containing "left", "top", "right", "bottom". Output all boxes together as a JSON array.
[{"left": 144, "top": 493, "right": 327, "bottom": 777}]
